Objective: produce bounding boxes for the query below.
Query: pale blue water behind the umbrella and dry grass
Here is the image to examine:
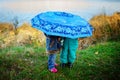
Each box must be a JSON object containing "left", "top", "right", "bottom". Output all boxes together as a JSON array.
[{"left": 0, "top": 0, "right": 120, "bottom": 24}]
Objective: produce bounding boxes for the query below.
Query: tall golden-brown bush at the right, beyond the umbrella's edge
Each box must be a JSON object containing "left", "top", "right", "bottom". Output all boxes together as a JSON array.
[{"left": 90, "top": 12, "right": 120, "bottom": 41}]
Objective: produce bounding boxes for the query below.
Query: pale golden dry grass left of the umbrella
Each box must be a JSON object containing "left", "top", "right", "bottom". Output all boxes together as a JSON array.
[{"left": 0, "top": 23, "right": 45, "bottom": 48}]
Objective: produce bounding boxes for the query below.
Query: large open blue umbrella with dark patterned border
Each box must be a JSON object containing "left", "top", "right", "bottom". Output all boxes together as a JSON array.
[{"left": 31, "top": 11, "right": 93, "bottom": 38}]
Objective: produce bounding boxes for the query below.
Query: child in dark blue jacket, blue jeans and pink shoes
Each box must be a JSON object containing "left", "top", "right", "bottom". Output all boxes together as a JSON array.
[{"left": 45, "top": 34, "right": 61, "bottom": 73}]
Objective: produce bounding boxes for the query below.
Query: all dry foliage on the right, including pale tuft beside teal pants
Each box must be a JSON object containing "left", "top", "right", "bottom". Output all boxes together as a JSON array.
[{"left": 79, "top": 12, "right": 120, "bottom": 49}]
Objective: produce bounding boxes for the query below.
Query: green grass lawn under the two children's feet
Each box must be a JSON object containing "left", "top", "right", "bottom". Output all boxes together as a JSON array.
[{"left": 0, "top": 41, "right": 120, "bottom": 80}]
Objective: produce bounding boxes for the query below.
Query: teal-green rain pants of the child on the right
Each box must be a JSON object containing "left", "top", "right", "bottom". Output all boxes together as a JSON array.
[{"left": 60, "top": 38, "right": 78, "bottom": 63}]
